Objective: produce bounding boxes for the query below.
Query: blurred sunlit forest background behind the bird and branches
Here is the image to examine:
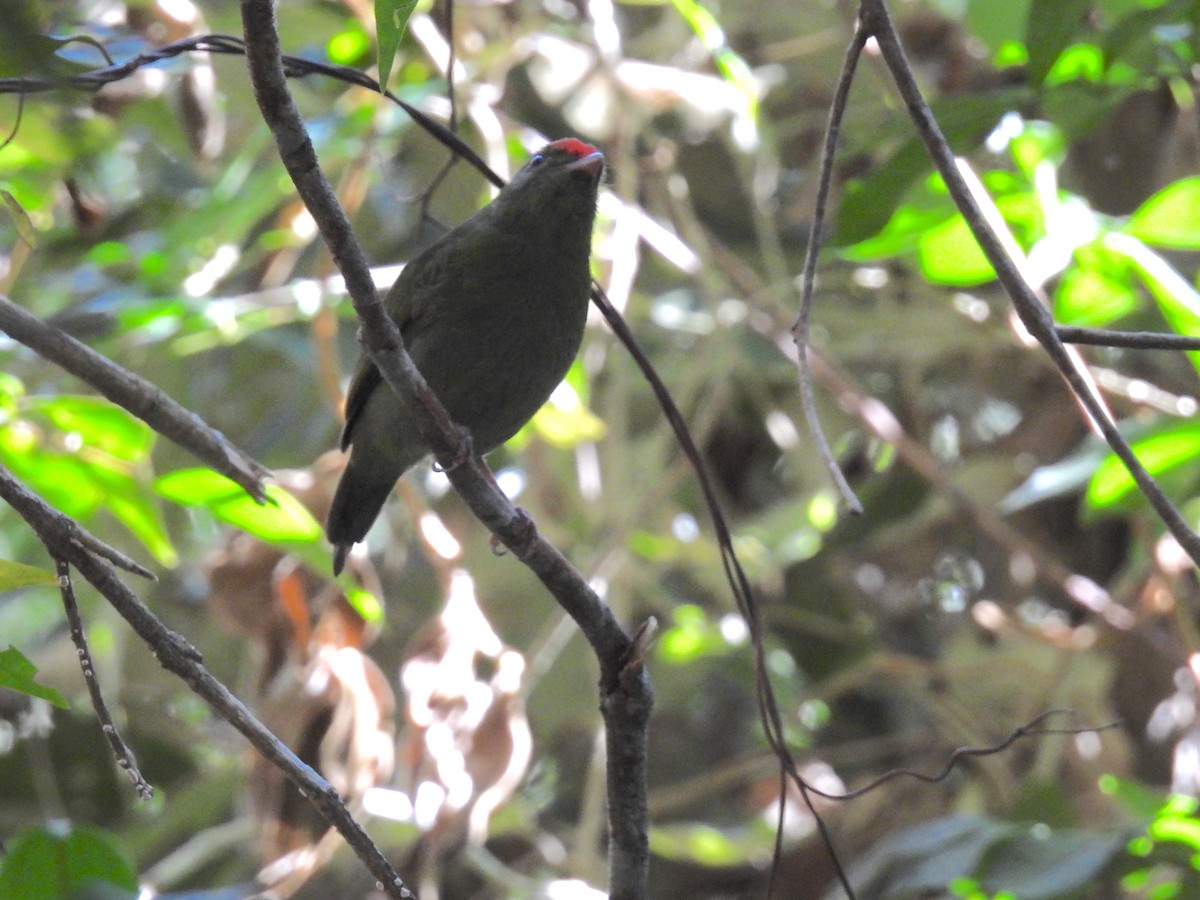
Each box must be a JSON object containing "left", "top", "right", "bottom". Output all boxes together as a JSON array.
[{"left": 0, "top": 0, "right": 1200, "bottom": 900}]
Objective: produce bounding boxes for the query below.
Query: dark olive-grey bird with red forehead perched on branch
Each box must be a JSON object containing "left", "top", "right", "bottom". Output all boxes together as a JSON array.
[{"left": 326, "top": 138, "right": 604, "bottom": 574}]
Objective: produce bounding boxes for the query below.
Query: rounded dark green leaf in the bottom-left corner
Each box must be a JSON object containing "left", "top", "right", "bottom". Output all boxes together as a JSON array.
[{"left": 0, "top": 826, "right": 138, "bottom": 900}]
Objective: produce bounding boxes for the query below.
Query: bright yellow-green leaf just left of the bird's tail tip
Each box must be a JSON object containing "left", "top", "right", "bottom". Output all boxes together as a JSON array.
[{"left": 156, "top": 469, "right": 322, "bottom": 544}]
